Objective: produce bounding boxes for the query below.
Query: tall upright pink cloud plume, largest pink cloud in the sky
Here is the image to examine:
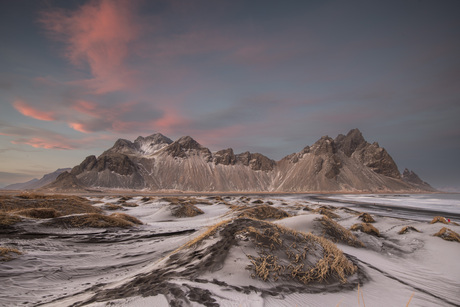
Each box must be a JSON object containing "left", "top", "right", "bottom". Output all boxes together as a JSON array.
[{"left": 40, "top": 0, "right": 141, "bottom": 94}]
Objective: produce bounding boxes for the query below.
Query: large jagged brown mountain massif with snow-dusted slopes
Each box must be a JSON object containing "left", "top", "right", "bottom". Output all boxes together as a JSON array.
[{"left": 45, "top": 129, "right": 434, "bottom": 192}]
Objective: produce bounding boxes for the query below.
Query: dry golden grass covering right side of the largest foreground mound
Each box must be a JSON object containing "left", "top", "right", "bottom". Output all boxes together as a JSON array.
[{"left": 241, "top": 220, "right": 357, "bottom": 284}]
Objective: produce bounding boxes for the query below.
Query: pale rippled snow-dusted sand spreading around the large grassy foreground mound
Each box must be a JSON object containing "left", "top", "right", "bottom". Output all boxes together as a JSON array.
[{"left": 0, "top": 194, "right": 460, "bottom": 306}]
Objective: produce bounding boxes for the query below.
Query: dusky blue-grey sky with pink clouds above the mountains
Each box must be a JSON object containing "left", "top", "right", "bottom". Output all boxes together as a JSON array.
[{"left": 0, "top": 0, "right": 460, "bottom": 191}]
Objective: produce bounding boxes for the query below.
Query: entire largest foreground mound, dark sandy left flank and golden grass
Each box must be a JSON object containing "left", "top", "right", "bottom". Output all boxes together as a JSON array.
[{"left": 169, "top": 218, "right": 358, "bottom": 284}]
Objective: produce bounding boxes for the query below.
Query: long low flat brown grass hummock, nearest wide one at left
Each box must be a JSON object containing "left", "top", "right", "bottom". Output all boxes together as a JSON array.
[{"left": 45, "top": 213, "right": 140, "bottom": 228}]
